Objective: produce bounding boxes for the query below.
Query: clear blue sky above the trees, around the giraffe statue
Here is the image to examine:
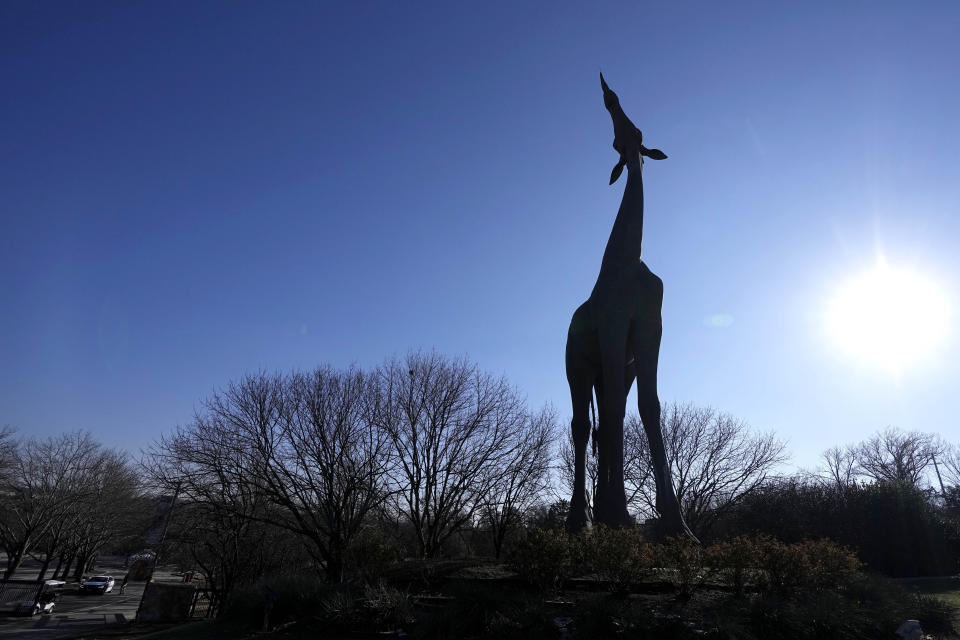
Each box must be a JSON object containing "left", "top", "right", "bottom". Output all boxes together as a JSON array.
[{"left": 0, "top": 1, "right": 960, "bottom": 466}]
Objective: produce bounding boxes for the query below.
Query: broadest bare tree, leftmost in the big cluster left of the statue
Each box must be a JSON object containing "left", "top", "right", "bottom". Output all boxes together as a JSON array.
[{"left": 147, "top": 367, "right": 389, "bottom": 581}]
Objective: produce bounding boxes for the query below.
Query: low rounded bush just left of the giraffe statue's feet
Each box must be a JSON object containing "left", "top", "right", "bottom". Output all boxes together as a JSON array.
[{"left": 508, "top": 529, "right": 583, "bottom": 593}]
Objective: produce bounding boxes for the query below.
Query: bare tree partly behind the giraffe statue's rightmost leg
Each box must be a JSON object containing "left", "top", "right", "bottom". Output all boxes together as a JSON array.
[{"left": 624, "top": 404, "right": 787, "bottom": 535}]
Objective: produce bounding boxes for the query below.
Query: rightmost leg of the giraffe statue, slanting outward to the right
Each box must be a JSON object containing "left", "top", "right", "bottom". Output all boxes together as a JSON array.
[{"left": 630, "top": 314, "right": 697, "bottom": 541}]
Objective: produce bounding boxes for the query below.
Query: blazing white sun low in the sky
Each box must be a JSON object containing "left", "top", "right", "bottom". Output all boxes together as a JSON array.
[{"left": 827, "top": 259, "right": 948, "bottom": 372}]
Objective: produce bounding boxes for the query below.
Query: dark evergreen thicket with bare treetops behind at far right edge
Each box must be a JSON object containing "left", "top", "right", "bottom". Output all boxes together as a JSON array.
[{"left": 715, "top": 428, "right": 960, "bottom": 577}]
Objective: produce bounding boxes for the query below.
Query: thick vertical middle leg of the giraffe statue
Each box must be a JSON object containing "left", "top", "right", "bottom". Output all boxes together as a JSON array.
[{"left": 594, "top": 314, "right": 633, "bottom": 527}]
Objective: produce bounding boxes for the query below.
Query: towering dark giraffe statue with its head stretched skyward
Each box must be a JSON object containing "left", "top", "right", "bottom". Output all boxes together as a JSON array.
[{"left": 566, "top": 74, "right": 696, "bottom": 540}]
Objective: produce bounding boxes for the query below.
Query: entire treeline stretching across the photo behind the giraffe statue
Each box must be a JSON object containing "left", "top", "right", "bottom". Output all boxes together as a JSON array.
[{"left": 0, "top": 352, "right": 960, "bottom": 599}]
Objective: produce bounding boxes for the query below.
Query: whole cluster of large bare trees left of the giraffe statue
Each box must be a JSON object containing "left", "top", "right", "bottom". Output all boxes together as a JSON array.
[{"left": 146, "top": 353, "right": 557, "bottom": 581}]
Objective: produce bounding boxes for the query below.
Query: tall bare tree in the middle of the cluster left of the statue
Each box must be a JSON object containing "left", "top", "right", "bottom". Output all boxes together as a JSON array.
[{"left": 377, "top": 353, "right": 526, "bottom": 556}]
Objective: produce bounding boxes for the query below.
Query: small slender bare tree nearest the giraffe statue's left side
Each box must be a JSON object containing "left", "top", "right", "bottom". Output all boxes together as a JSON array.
[{"left": 482, "top": 407, "right": 557, "bottom": 558}]
